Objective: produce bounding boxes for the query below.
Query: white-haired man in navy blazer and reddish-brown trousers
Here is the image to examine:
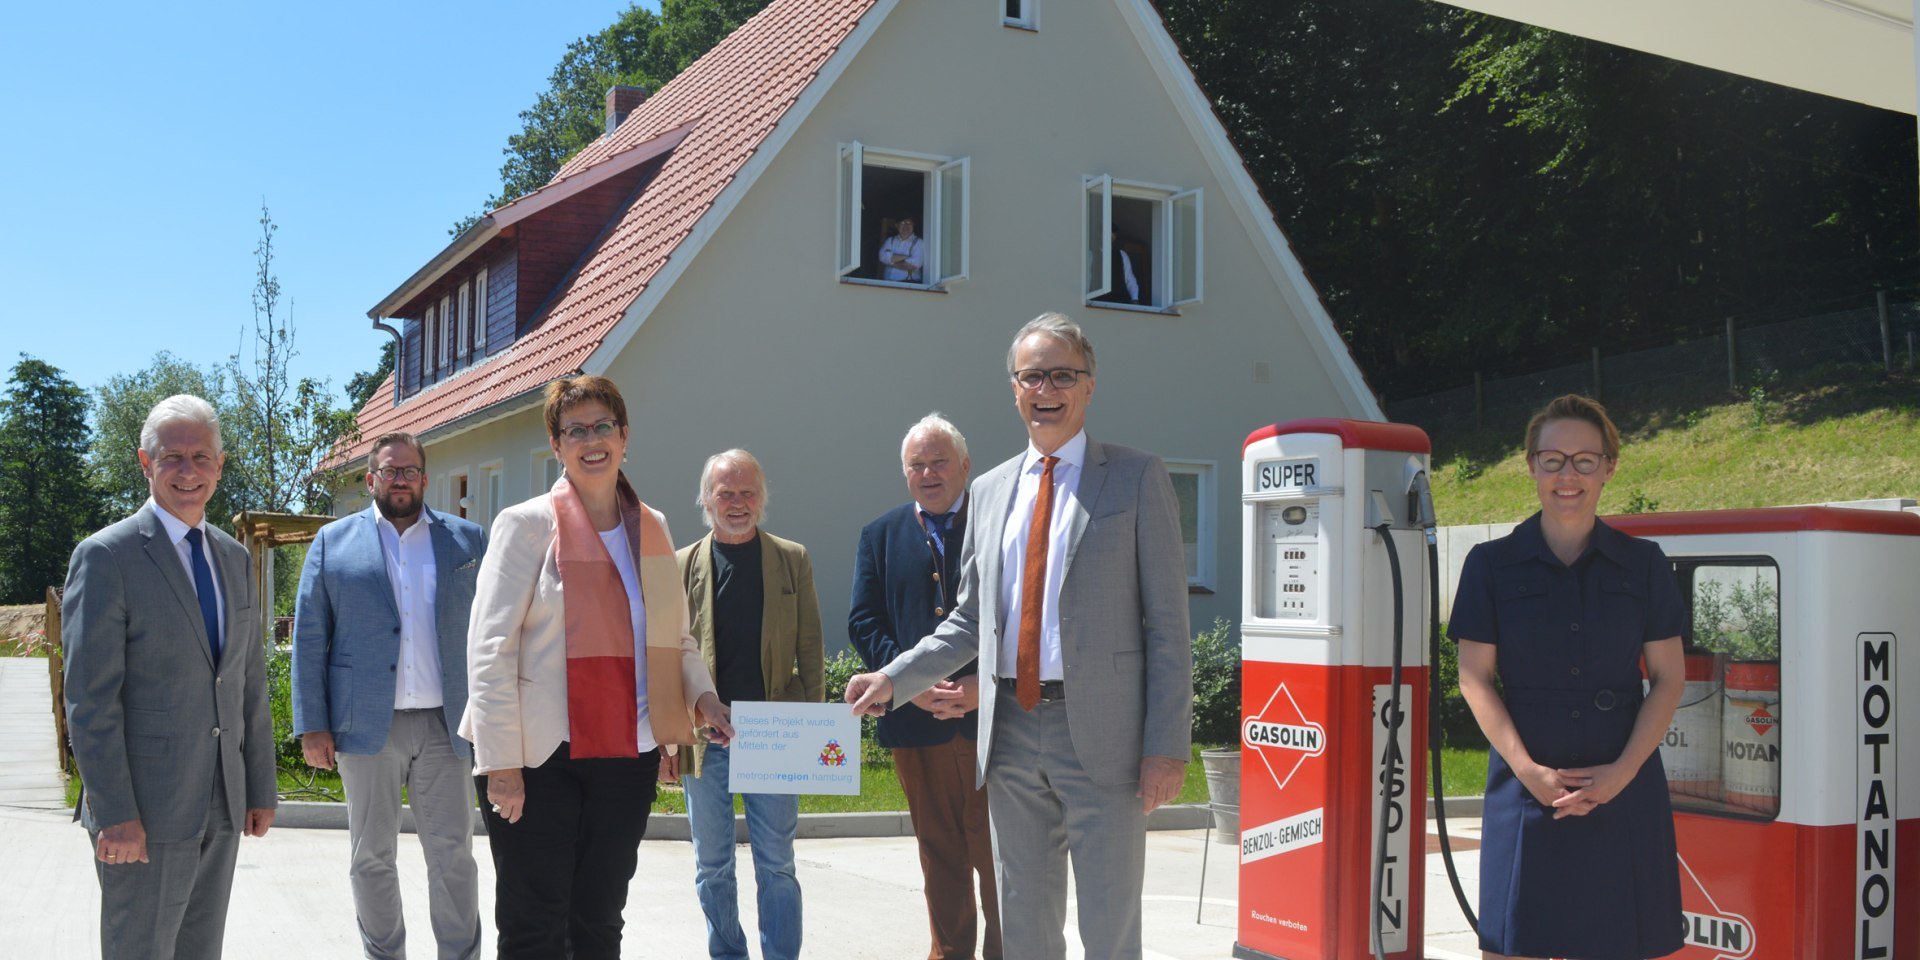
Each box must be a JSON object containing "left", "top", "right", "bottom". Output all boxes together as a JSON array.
[{"left": 847, "top": 413, "right": 1000, "bottom": 960}]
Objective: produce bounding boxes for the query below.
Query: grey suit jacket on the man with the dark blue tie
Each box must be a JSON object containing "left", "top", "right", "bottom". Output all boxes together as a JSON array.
[{"left": 60, "top": 505, "right": 278, "bottom": 843}]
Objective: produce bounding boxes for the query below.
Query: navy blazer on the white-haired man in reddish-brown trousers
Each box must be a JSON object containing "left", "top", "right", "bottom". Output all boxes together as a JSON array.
[{"left": 847, "top": 497, "right": 979, "bottom": 747}]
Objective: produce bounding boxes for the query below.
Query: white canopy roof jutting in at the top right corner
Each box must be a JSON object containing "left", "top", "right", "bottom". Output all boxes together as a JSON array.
[{"left": 1442, "top": 0, "right": 1920, "bottom": 113}]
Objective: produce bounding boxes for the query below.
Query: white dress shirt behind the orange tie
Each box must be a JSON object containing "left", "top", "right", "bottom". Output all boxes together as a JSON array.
[{"left": 1000, "top": 430, "right": 1087, "bottom": 680}]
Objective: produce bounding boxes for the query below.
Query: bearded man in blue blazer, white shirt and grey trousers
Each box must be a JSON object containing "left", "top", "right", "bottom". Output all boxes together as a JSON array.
[{"left": 294, "top": 434, "right": 486, "bottom": 960}]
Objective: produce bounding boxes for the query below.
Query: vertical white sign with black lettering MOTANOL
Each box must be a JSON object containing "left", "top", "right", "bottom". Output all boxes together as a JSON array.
[{"left": 1853, "top": 634, "right": 1912, "bottom": 960}]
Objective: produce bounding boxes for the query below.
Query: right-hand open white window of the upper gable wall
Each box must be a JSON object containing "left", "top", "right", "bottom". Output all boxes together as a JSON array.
[{"left": 1083, "top": 175, "right": 1206, "bottom": 309}]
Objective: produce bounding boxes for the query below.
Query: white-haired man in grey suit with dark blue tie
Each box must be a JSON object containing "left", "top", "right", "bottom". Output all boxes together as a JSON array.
[{"left": 60, "top": 394, "right": 278, "bottom": 960}]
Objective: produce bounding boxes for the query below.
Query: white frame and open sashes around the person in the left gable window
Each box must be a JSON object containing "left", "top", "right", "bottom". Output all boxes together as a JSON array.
[{"left": 833, "top": 140, "right": 973, "bottom": 292}]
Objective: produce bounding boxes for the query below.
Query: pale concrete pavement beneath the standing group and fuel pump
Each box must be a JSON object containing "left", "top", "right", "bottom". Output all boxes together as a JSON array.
[{"left": 0, "top": 806, "right": 1478, "bottom": 960}]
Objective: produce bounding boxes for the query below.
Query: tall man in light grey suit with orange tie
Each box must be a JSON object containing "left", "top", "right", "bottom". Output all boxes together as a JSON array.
[{"left": 847, "top": 313, "right": 1192, "bottom": 960}]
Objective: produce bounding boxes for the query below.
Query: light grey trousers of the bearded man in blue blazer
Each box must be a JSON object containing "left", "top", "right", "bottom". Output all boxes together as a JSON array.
[{"left": 334, "top": 707, "right": 480, "bottom": 960}]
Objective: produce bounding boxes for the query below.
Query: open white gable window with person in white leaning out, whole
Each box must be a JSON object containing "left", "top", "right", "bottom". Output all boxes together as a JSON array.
[{"left": 835, "top": 142, "right": 970, "bottom": 288}]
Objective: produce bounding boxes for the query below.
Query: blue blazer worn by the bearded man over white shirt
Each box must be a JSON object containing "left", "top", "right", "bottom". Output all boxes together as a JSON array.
[{"left": 294, "top": 507, "right": 486, "bottom": 756}]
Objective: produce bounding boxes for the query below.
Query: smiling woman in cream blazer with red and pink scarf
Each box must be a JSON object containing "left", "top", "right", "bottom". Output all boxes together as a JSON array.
[{"left": 461, "top": 376, "right": 733, "bottom": 960}]
